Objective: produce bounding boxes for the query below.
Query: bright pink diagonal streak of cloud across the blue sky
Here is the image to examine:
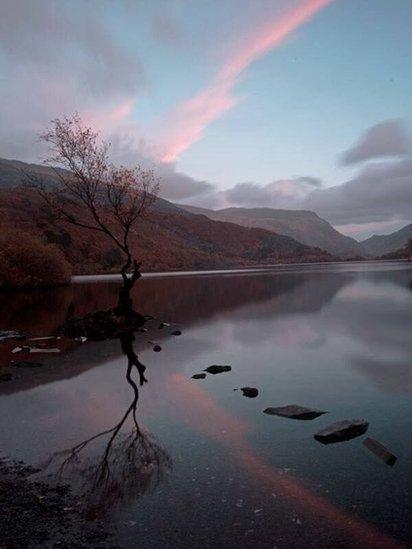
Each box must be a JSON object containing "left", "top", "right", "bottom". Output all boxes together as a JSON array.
[{"left": 158, "top": 0, "right": 334, "bottom": 163}]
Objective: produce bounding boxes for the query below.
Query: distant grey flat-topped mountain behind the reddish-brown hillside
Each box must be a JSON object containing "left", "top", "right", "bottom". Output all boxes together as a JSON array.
[{"left": 180, "top": 206, "right": 365, "bottom": 258}]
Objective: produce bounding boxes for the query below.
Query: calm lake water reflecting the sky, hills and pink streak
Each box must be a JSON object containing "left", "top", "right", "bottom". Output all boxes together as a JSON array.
[{"left": 0, "top": 262, "right": 412, "bottom": 548}]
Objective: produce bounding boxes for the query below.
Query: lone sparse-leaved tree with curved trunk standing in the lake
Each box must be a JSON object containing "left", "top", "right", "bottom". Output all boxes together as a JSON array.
[{"left": 28, "top": 114, "right": 159, "bottom": 310}]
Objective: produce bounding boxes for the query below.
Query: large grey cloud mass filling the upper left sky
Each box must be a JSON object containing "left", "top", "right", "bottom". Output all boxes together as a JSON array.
[{"left": 0, "top": 0, "right": 147, "bottom": 160}]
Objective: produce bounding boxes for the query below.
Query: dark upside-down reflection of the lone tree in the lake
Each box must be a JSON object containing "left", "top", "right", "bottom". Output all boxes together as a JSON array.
[{"left": 46, "top": 332, "right": 173, "bottom": 519}]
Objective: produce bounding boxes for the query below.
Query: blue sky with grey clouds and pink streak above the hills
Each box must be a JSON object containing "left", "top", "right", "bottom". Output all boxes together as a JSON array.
[{"left": 0, "top": 0, "right": 412, "bottom": 239}]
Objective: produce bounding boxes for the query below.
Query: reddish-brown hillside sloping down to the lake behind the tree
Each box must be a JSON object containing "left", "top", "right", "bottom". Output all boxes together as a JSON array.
[{"left": 0, "top": 157, "right": 333, "bottom": 273}]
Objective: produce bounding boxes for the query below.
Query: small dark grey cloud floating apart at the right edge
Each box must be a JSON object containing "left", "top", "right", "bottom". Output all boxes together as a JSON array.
[{"left": 341, "top": 120, "right": 411, "bottom": 165}]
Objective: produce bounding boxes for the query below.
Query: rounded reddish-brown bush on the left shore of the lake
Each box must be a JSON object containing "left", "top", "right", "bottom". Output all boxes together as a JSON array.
[{"left": 0, "top": 228, "right": 71, "bottom": 288}]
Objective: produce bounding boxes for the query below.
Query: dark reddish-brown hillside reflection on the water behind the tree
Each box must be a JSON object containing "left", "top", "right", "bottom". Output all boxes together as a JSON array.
[{"left": 0, "top": 272, "right": 348, "bottom": 335}]
